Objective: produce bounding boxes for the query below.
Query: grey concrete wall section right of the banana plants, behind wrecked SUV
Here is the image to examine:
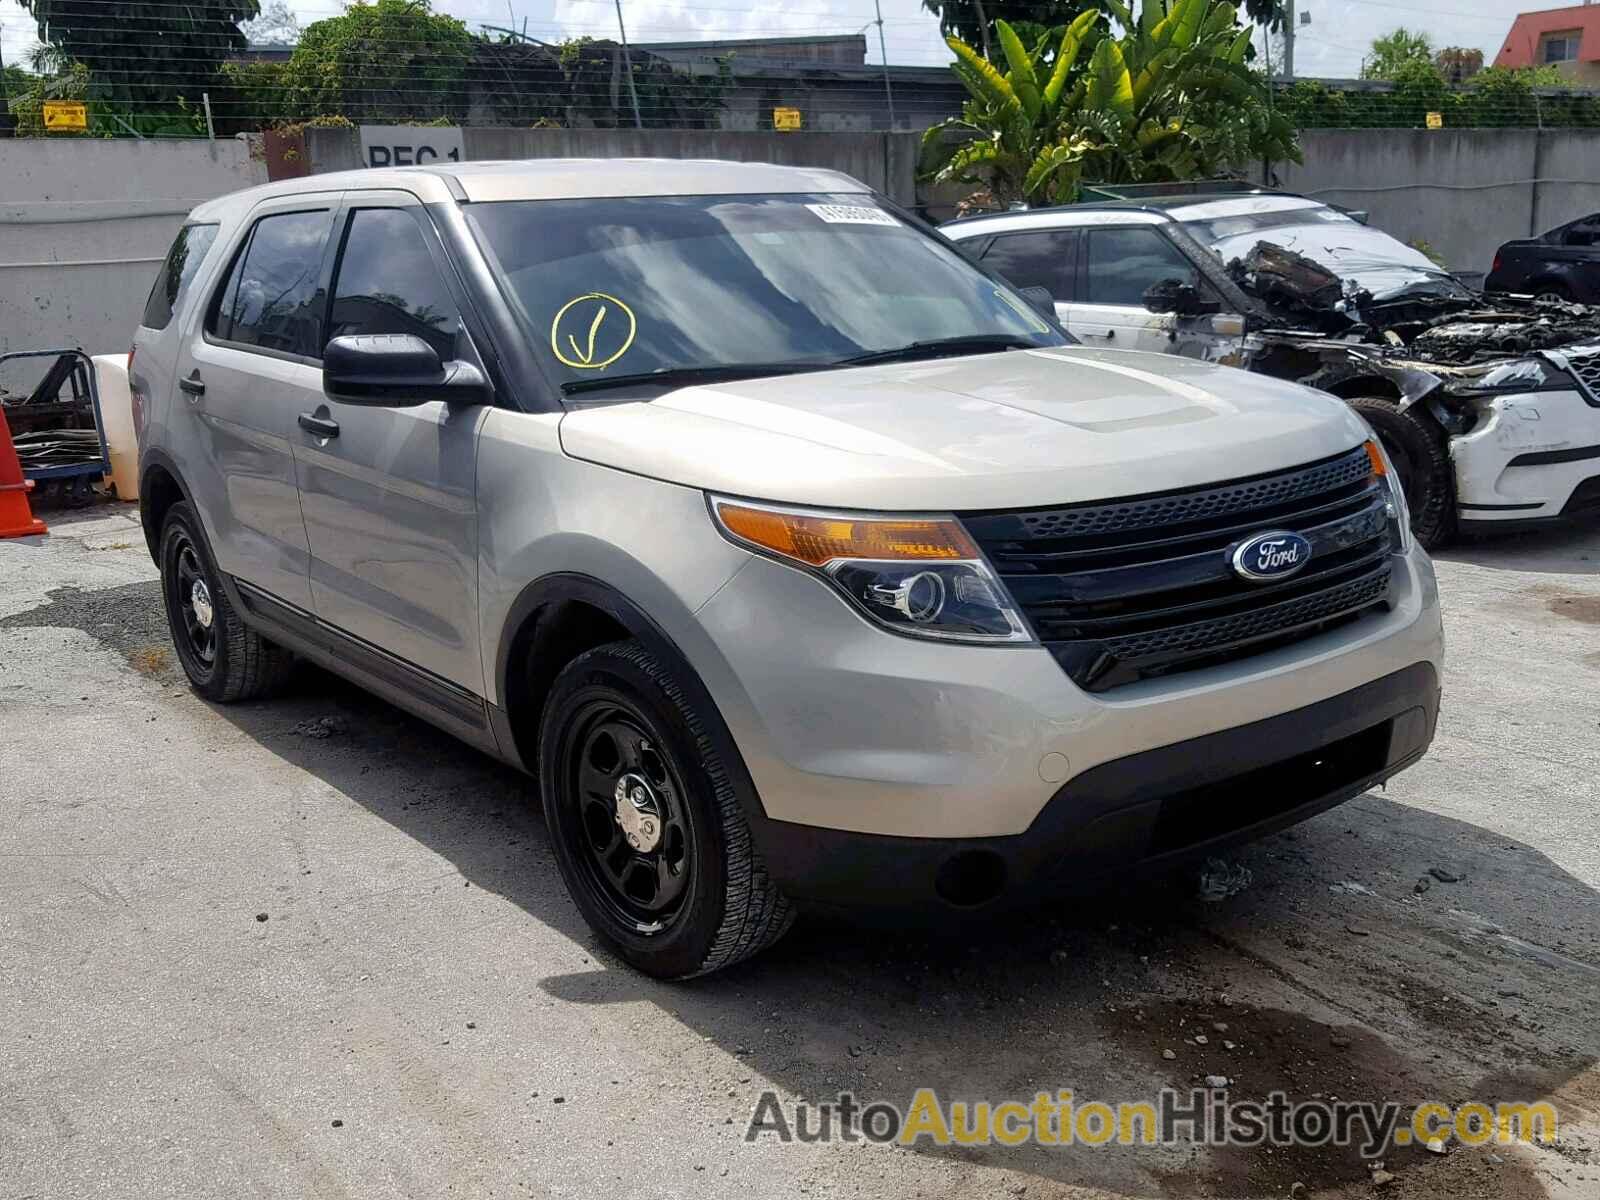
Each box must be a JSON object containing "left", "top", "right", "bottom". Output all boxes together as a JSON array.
[{"left": 1274, "top": 130, "right": 1600, "bottom": 280}]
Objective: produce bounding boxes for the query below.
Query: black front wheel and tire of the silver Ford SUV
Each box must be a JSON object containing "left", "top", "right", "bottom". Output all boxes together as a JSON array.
[{"left": 539, "top": 642, "right": 794, "bottom": 979}]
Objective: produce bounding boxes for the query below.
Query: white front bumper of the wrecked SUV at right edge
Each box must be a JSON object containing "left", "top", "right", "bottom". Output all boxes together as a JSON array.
[{"left": 1450, "top": 390, "right": 1600, "bottom": 523}]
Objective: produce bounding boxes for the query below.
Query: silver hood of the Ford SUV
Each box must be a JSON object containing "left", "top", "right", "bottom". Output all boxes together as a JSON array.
[{"left": 560, "top": 347, "right": 1366, "bottom": 512}]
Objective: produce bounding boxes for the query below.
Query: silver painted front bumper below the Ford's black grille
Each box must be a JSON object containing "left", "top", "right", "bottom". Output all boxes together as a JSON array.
[{"left": 694, "top": 550, "right": 1443, "bottom": 853}]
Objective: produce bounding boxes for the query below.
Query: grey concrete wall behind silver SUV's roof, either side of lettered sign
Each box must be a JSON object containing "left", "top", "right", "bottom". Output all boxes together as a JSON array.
[{"left": 306, "top": 128, "right": 918, "bottom": 205}]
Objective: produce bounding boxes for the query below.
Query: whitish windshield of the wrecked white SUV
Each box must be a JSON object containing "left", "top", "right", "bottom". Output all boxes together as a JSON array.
[{"left": 1182, "top": 205, "right": 1472, "bottom": 299}]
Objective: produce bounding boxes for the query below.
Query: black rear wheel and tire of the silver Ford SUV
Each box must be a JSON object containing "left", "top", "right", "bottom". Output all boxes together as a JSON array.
[{"left": 160, "top": 501, "right": 294, "bottom": 704}]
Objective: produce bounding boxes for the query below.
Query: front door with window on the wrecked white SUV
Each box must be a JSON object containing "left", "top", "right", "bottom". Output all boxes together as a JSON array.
[{"left": 1064, "top": 226, "right": 1243, "bottom": 358}]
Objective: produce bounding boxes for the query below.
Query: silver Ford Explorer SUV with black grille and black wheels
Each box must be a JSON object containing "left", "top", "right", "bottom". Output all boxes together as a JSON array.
[{"left": 131, "top": 160, "right": 1442, "bottom": 976}]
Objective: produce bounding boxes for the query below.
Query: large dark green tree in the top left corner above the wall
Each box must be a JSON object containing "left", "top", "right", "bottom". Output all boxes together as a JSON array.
[{"left": 19, "top": 0, "right": 259, "bottom": 112}]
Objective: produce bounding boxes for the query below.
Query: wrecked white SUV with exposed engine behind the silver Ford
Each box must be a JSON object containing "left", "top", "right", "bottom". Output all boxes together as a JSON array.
[{"left": 941, "top": 192, "right": 1600, "bottom": 547}]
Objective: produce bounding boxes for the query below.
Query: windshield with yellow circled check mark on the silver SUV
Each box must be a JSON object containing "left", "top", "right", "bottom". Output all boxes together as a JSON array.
[{"left": 464, "top": 194, "right": 1067, "bottom": 384}]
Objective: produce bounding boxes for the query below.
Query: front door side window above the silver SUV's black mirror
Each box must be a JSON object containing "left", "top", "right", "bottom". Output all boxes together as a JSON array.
[{"left": 328, "top": 208, "right": 461, "bottom": 362}]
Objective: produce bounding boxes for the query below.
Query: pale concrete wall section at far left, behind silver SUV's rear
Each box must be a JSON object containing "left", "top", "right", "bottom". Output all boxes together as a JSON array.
[{"left": 0, "top": 138, "right": 266, "bottom": 354}]
